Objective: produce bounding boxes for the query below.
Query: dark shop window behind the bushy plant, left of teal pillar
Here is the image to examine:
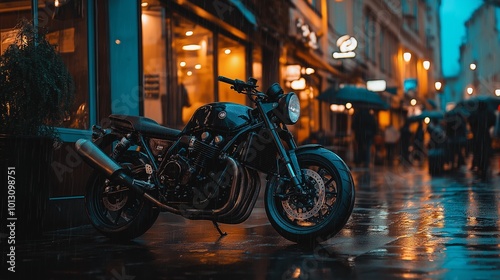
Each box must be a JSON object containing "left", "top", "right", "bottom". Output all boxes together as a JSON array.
[{"left": 0, "top": 0, "right": 90, "bottom": 129}]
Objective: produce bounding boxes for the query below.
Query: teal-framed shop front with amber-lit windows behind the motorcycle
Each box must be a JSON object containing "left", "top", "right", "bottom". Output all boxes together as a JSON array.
[{"left": 0, "top": 0, "right": 289, "bottom": 229}]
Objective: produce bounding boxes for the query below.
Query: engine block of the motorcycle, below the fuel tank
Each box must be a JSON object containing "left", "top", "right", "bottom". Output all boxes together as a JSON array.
[{"left": 160, "top": 132, "right": 228, "bottom": 205}]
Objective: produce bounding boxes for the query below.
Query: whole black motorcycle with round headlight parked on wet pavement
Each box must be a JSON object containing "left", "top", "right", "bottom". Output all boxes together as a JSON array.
[{"left": 75, "top": 77, "right": 355, "bottom": 244}]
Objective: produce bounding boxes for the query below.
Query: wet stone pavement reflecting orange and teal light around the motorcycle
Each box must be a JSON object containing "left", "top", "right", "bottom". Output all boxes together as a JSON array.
[{"left": 2, "top": 161, "right": 500, "bottom": 279}]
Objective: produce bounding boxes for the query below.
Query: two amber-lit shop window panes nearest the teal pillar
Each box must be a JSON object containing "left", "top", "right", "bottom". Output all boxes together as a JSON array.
[{"left": 142, "top": 5, "right": 214, "bottom": 128}]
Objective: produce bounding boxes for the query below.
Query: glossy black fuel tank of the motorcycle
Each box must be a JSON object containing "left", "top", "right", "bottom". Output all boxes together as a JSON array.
[{"left": 184, "top": 102, "right": 252, "bottom": 134}]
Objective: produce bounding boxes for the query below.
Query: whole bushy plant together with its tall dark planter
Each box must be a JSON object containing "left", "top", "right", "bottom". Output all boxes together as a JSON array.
[{"left": 0, "top": 19, "right": 74, "bottom": 236}]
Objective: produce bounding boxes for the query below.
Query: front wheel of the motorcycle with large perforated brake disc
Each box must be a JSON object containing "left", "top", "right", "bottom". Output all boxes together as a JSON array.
[{"left": 264, "top": 148, "right": 355, "bottom": 245}]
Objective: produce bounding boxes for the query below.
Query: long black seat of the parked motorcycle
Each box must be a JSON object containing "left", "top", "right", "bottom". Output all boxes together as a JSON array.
[{"left": 109, "top": 115, "right": 181, "bottom": 139}]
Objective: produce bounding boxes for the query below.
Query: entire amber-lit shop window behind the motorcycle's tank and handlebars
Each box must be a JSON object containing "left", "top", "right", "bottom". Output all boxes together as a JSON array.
[{"left": 141, "top": 1, "right": 254, "bottom": 129}]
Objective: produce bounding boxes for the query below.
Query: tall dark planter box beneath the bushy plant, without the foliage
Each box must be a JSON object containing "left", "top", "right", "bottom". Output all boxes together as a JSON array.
[{"left": 0, "top": 134, "right": 53, "bottom": 240}]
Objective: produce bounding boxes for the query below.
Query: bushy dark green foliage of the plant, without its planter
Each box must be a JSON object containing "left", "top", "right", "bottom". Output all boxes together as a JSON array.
[{"left": 0, "top": 19, "right": 74, "bottom": 137}]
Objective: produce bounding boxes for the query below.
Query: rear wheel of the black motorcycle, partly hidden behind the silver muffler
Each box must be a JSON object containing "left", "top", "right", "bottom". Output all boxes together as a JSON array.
[{"left": 85, "top": 151, "right": 160, "bottom": 240}]
